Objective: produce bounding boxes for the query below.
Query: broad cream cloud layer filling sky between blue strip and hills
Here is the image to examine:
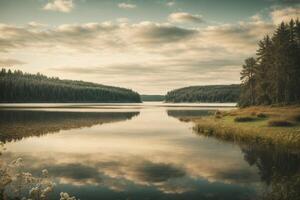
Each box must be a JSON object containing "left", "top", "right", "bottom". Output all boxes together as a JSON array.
[{"left": 0, "top": 12, "right": 274, "bottom": 94}]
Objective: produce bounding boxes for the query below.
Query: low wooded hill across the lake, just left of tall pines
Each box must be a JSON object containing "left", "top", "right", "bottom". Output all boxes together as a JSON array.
[{"left": 165, "top": 84, "right": 240, "bottom": 103}]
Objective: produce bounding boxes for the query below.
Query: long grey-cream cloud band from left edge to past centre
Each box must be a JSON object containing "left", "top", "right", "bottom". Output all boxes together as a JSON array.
[{"left": 0, "top": 22, "right": 197, "bottom": 51}]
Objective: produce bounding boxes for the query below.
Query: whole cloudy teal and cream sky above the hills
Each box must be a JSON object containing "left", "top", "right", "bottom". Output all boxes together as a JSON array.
[{"left": 0, "top": 0, "right": 300, "bottom": 94}]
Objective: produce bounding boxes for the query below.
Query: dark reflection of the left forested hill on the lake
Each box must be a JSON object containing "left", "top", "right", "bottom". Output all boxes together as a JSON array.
[{"left": 0, "top": 110, "right": 139, "bottom": 142}]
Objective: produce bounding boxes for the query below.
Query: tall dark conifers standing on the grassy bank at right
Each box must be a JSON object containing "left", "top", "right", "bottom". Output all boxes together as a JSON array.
[{"left": 240, "top": 20, "right": 300, "bottom": 106}]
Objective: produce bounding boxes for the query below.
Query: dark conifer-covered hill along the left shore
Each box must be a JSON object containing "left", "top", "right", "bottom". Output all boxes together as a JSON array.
[{"left": 0, "top": 68, "right": 141, "bottom": 102}]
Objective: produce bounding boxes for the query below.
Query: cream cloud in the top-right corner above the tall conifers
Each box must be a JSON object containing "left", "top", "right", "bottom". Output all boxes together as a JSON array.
[{"left": 270, "top": 6, "right": 300, "bottom": 25}]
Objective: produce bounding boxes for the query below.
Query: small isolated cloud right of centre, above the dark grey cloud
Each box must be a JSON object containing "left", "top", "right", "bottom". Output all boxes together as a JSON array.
[{"left": 169, "top": 12, "right": 204, "bottom": 23}]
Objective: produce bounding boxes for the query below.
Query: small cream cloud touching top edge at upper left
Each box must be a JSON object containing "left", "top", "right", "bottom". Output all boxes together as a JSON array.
[{"left": 43, "top": 0, "right": 74, "bottom": 13}]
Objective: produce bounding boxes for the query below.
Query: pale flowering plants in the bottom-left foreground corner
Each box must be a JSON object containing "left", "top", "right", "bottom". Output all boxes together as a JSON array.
[{"left": 0, "top": 142, "right": 76, "bottom": 200}]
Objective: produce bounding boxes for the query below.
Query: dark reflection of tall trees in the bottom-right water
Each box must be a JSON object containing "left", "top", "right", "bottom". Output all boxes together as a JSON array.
[{"left": 240, "top": 144, "right": 300, "bottom": 200}]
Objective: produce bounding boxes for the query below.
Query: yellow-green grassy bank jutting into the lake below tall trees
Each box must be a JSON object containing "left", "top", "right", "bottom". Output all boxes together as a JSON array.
[{"left": 193, "top": 106, "right": 300, "bottom": 148}]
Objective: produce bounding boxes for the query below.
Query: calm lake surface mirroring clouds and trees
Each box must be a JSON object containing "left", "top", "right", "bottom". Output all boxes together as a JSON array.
[{"left": 0, "top": 103, "right": 300, "bottom": 200}]
